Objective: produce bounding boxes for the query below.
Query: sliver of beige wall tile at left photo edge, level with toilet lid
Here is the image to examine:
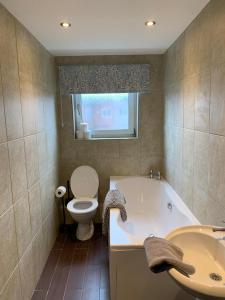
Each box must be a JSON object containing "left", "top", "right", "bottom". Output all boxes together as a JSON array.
[{"left": 0, "top": 144, "right": 12, "bottom": 215}]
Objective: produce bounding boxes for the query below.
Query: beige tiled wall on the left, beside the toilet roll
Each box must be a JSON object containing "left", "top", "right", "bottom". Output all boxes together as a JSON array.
[{"left": 0, "top": 5, "right": 58, "bottom": 300}]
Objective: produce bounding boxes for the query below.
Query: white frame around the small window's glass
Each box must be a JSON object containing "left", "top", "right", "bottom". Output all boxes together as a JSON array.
[{"left": 72, "top": 93, "right": 139, "bottom": 139}]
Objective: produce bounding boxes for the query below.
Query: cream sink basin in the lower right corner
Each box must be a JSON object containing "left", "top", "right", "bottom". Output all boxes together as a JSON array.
[{"left": 166, "top": 225, "right": 225, "bottom": 300}]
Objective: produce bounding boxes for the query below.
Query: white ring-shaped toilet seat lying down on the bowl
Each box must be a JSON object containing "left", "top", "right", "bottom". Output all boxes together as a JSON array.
[{"left": 67, "top": 197, "right": 98, "bottom": 214}]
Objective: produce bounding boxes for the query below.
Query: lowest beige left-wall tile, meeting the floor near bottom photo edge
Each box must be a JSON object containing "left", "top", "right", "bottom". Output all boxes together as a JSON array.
[{"left": 19, "top": 246, "right": 35, "bottom": 300}]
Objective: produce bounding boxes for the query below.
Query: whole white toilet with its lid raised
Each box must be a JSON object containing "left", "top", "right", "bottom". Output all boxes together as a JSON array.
[{"left": 67, "top": 166, "right": 99, "bottom": 241}]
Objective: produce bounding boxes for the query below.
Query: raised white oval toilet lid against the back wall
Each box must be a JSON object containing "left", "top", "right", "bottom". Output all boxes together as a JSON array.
[{"left": 70, "top": 166, "right": 99, "bottom": 198}]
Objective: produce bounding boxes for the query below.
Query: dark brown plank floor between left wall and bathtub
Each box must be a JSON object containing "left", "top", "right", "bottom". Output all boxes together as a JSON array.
[{"left": 32, "top": 226, "right": 110, "bottom": 300}]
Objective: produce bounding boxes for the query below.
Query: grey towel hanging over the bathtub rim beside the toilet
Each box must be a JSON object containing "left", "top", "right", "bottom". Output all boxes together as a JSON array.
[{"left": 102, "top": 190, "right": 127, "bottom": 235}]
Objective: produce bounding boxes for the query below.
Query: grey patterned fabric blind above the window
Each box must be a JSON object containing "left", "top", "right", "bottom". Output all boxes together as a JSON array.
[{"left": 58, "top": 64, "right": 150, "bottom": 95}]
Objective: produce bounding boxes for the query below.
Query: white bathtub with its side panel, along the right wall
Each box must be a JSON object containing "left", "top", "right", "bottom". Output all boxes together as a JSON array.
[{"left": 109, "top": 176, "right": 199, "bottom": 300}]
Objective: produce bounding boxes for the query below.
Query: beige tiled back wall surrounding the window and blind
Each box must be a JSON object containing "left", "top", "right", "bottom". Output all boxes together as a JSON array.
[{"left": 56, "top": 55, "right": 163, "bottom": 221}]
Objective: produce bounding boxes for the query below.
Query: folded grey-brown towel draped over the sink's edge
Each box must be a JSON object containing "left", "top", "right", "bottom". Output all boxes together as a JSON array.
[{"left": 144, "top": 237, "right": 195, "bottom": 277}]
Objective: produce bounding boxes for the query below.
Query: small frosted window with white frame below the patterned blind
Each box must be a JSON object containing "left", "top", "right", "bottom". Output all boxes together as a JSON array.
[{"left": 73, "top": 93, "right": 138, "bottom": 138}]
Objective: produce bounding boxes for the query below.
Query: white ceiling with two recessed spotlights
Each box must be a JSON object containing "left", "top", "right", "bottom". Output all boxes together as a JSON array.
[{"left": 0, "top": 0, "right": 209, "bottom": 55}]
